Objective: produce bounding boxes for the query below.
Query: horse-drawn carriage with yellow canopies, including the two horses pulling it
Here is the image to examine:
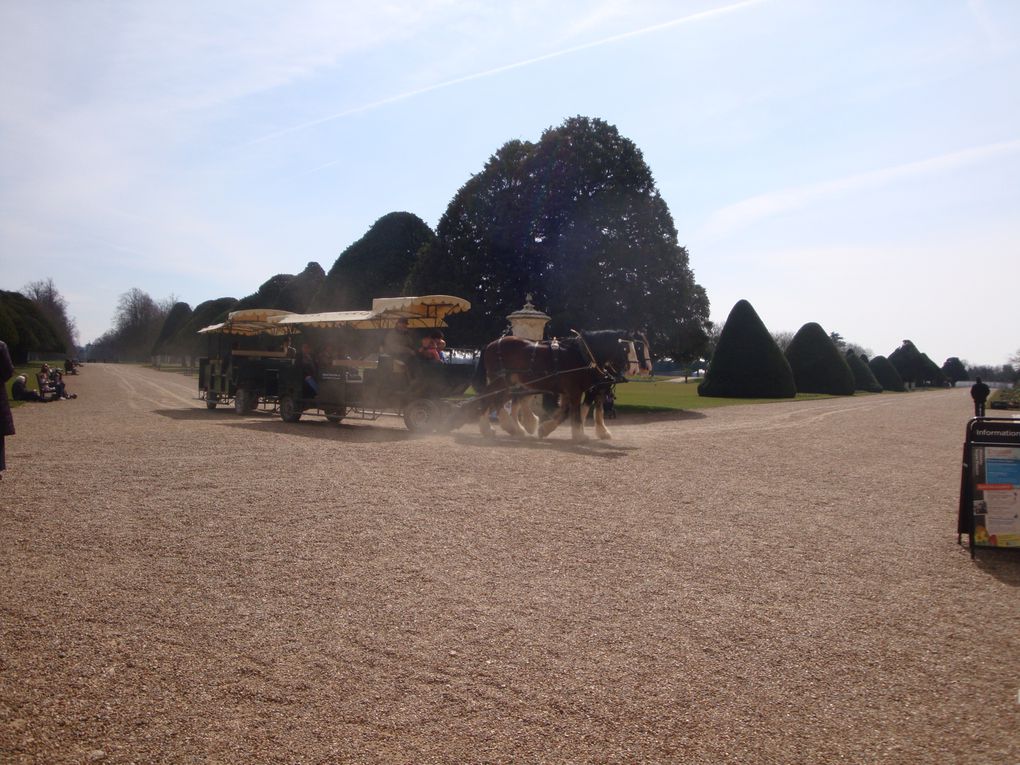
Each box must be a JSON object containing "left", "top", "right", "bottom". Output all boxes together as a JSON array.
[{"left": 199, "top": 295, "right": 651, "bottom": 439}]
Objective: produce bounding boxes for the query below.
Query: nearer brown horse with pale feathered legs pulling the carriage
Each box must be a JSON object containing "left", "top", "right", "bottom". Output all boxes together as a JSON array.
[{"left": 473, "top": 329, "right": 628, "bottom": 441}]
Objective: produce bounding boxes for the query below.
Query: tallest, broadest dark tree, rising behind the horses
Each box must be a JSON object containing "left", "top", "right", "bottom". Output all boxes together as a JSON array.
[{"left": 401, "top": 116, "right": 709, "bottom": 358}]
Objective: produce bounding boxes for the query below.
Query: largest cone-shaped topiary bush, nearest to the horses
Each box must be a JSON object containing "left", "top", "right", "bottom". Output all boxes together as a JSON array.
[{"left": 698, "top": 300, "right": 797, "bottom": 399}]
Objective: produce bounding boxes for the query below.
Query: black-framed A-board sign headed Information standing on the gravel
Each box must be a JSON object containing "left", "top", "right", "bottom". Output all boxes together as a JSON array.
[{"left": 957, "top": 417, "right": 1020, "bottom": 558}]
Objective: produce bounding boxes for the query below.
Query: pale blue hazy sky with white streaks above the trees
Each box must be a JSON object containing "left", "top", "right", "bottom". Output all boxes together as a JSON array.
[{"left": 0, "top": 0, "right": 1020, "bottom": 365}]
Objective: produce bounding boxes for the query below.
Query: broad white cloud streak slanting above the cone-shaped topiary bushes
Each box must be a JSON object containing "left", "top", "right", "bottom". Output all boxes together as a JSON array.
[{"left": 704, "top": 139, "right": 1020, "bottom": 238}]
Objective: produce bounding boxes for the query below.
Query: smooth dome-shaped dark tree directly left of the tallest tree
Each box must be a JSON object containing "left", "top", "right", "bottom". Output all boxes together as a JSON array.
[{"left": 309, "top": 212, "right": 436, "bottom": 311}]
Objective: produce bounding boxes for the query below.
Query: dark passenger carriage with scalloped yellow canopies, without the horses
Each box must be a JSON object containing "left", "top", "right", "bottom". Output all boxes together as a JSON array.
[{"left": 199, "top": 295, "right": 475, "bottom": 430}]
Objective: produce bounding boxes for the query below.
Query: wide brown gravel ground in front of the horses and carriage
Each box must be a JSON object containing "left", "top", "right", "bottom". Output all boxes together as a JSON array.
[{"left": 0, "top": 364, "right": 1020, "bottom": 765}]
